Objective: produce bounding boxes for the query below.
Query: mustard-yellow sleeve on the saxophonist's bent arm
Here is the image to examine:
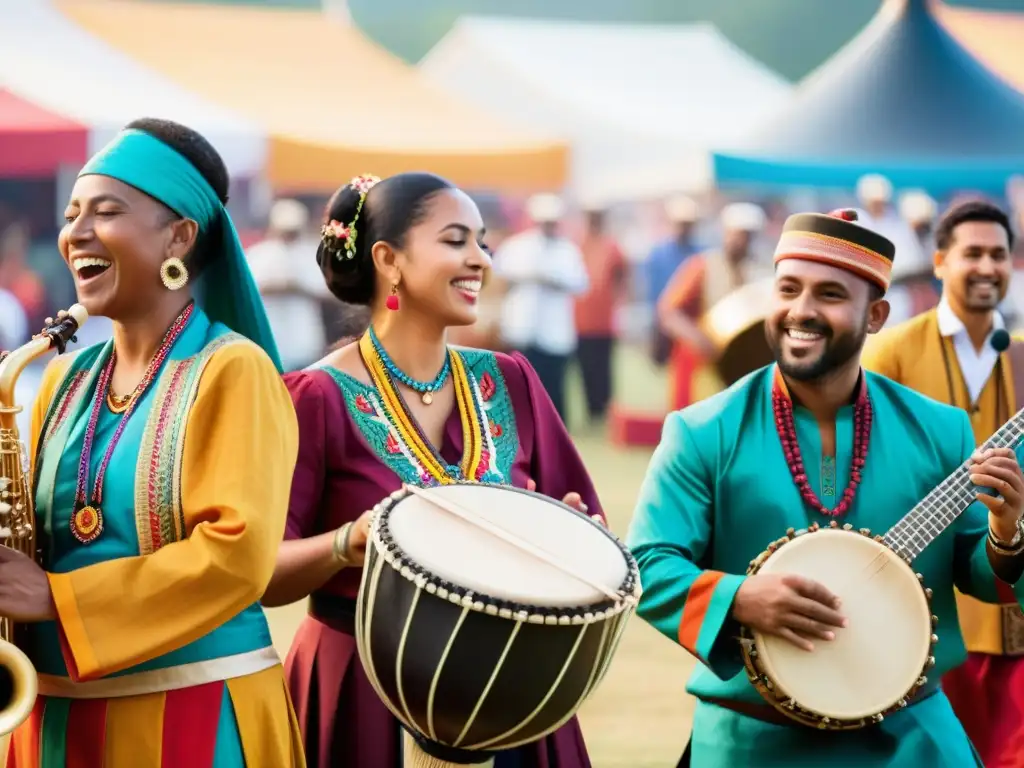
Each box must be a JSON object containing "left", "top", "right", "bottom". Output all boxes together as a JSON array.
[{"left": 49, "top": 343, "right": 299, "bottom": 680}]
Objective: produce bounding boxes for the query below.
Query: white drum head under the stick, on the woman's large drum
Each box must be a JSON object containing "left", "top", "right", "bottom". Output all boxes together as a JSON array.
[{"left": 386, "top": 484, "right": 632, "bottom": 608}]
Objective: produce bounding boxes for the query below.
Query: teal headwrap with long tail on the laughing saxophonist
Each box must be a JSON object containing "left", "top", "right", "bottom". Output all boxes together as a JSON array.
[{"left": 79, "top": 130, "right": 282, "bottom": 371}]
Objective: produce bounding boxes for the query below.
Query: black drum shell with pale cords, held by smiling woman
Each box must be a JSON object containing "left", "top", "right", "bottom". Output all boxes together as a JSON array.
[{"left": 356, "top": 547, "right": 632, "bottom": 752}]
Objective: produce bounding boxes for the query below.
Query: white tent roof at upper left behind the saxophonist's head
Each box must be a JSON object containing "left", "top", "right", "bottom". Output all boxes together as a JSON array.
[{"left": 0, "top": 0, "right": 266, "bottom": 177}]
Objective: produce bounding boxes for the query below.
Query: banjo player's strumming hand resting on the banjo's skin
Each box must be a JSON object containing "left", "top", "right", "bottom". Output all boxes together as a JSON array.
[{"left": 732, "top": 573, "right": 847, "bottom": 651}]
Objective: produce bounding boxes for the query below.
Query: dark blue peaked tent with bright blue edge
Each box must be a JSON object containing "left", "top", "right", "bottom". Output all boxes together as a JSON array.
[{"left": 714, "top": 0, "right": 1024, "bottom": 197}]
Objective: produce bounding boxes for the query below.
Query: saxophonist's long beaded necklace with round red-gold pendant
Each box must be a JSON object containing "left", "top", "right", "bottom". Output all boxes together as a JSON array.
[{"left": 71, "top": 301, "right": 194, "bottom": 544}]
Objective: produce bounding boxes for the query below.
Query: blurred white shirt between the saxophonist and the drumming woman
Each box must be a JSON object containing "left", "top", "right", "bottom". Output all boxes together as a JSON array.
[{"left": 247, "top": 239, "right": 331, "bottom": 372}]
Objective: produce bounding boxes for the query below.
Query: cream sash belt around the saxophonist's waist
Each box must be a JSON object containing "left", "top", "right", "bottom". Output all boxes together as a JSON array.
[{"left": 39, "top": 646, "right": 281, "bottom": 698}]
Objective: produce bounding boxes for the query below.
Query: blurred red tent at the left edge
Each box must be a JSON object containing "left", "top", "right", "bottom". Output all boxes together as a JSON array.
[{"left": 0, "top": 88, "right": 89, "bottom": 177}]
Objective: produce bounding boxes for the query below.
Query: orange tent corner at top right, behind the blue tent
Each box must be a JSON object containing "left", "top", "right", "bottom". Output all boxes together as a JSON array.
[{"left": 935, "top": 4, "right": 1024, "bottom": 91}]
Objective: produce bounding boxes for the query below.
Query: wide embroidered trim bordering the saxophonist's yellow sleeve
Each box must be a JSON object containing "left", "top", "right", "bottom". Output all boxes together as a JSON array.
[{"left": 135, "top": 333, "right": 247, "bottom": 555}]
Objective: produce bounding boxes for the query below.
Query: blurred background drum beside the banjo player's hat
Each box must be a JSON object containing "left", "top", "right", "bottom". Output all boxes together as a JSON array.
[{"left": 700, "top": 278, "right": 775, "bottom": 386}]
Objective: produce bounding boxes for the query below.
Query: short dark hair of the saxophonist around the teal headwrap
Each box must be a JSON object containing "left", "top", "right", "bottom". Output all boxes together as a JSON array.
[{"left": 125, "top": 118, "right": 230, "bottom": 275}]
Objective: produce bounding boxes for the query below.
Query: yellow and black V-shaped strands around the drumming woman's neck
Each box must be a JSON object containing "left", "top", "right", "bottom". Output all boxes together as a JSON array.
[{"left": 359, "top": 334, "right": 501, "bottom": 485}]
